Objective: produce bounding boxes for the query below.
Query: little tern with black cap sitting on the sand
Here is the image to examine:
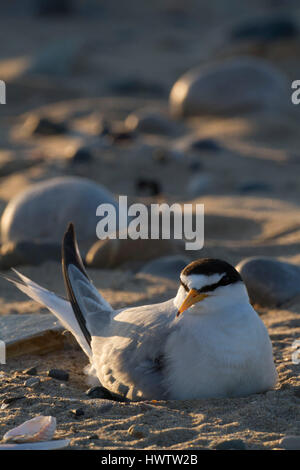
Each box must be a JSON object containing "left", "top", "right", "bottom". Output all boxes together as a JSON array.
[{"left": 7, "top": 224, "right": 277, "bottom": 400}]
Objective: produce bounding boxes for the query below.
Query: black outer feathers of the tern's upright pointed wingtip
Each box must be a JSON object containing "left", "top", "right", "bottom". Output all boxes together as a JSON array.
[{"left": 62, "top": 223, "right": 91, "bottom": 345}]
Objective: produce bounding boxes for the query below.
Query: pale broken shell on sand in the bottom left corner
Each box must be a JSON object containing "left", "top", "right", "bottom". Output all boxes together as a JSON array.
[{"left": 3, "top": 416, "right": 56, "bottom": 442}]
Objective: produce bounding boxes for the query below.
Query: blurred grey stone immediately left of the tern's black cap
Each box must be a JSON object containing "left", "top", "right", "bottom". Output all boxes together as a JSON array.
[{"left": 140, "top": 255, "right": 190, "bottom": 281}]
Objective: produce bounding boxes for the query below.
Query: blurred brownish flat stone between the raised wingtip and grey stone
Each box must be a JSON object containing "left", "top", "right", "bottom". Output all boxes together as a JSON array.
[{"left": 85, "top": 238, "right": 179, "bottom": 269}]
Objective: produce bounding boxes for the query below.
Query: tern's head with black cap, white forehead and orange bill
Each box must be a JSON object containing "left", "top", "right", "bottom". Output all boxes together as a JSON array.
[{"left": 174, "top": 258, "right": 248, "bottom": 316}]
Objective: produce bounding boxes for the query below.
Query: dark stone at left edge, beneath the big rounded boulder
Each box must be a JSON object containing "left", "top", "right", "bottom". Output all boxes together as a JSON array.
[{"left": 0, "top": 240, "right": 61, "bottom": 269}]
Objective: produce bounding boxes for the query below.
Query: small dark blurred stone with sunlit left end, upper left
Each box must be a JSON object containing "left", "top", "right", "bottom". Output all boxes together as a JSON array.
[{"left": 23, "top": 114, "right": 67, "bottom": 136}]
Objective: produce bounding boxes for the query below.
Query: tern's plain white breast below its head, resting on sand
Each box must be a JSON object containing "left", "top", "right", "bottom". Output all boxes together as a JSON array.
[{"left": 166, "top": 304, "right": 277, "bottom": 399}]
